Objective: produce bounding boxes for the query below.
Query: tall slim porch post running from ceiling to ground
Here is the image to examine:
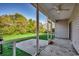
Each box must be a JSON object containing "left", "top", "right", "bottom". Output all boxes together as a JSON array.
[{"left": 36, "top": 3, "right": 39, "bottom": 55}]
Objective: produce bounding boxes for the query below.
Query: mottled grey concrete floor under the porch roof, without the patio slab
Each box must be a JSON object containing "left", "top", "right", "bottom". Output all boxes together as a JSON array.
[{"left": 39, "top": 39, "right": 77, "bottom": 56}]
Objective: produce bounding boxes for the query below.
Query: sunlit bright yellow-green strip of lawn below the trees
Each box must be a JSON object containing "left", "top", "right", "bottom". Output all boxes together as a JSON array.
[{"left": 3, "top": 33, "right": 45, "bottom": 41}]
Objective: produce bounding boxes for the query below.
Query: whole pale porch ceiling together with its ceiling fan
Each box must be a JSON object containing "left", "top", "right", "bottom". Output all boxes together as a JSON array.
[{"left": 32, "top": 3, "right": 75, "bottom": 20}]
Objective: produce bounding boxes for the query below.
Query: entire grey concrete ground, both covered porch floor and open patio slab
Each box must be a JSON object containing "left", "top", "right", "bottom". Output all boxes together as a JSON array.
[{"left": 16, "top": 39, "right": 78, "bottom": 56}]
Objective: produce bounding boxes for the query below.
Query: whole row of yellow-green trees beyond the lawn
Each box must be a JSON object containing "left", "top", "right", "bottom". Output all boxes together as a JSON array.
[{"left": 0, "top": 13, "right": 45, "bottom": 35}]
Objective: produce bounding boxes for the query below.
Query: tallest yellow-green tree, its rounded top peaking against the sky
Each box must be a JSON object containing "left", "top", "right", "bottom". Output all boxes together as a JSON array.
[{"left": 15, "top": 13, "right": 27, "bottom": 34}]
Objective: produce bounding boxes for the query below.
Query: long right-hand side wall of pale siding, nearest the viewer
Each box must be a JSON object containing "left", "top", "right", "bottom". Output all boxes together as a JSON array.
[{"left": 69, "top": 4, "right": 79, "bottom": 53}]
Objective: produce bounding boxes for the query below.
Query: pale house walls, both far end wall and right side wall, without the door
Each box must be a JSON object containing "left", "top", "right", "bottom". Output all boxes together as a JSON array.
[{"left": 55, "top": 4, "right": 79, "bottom": 53}]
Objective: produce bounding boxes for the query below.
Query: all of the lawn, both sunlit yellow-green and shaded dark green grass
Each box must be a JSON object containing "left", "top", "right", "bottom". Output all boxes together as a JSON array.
[{"left": 2, "top": 33, "right": 54, "bottom": 56}]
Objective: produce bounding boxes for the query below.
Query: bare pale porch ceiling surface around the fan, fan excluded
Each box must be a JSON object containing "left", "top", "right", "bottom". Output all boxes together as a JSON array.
[{"left": 39, "top": 3, "right": 75, "bottom": 20}]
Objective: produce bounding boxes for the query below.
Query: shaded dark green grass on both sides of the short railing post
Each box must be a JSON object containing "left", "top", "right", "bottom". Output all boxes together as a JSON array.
[{"left": 2, "top": 43, "right": 31, "bottom": 56}]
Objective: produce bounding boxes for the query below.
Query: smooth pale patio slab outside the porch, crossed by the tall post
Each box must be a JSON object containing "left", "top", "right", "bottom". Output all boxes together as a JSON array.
[{"left": 16, "top": 39, "right": 48, "bottom": 55}]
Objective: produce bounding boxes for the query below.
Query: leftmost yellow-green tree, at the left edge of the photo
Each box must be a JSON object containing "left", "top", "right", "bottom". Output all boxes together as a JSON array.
[{"left": 0, "top": 15, "right": 14, "bottom": 34}]
